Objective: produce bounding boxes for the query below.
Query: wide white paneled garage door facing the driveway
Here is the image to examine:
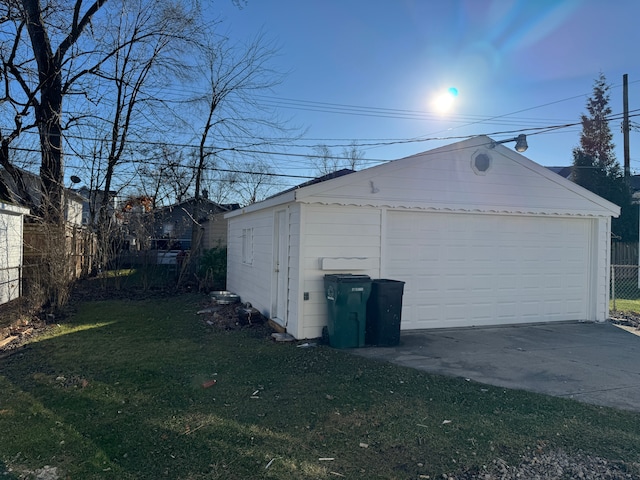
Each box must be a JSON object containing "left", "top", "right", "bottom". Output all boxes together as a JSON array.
[{"left": 386, "top": 211, "right": 591, "bottom": 329}]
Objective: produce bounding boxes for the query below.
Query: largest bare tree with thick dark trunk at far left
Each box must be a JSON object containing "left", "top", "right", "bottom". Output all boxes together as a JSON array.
[{"left": 0, "top": 0, "right": 106, "bottom": 223}]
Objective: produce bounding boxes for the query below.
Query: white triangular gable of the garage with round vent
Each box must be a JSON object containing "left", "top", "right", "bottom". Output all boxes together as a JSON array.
[{"left": 294, "top": 136, "right": 620, "bottom": 217}]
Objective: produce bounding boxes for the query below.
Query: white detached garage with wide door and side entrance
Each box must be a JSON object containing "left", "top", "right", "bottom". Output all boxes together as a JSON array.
[{"left": 225, "top": 136, "right": 620, "bottom": 338}]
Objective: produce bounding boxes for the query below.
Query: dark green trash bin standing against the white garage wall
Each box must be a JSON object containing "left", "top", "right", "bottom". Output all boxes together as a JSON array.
[{"left": 324, "top": 273, "right": 371, "bottom": 348}]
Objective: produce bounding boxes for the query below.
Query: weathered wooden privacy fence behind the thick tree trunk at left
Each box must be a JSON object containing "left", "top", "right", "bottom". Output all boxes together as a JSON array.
[{"left": 23, "top": 223, "right": 98, "bottom": 280}]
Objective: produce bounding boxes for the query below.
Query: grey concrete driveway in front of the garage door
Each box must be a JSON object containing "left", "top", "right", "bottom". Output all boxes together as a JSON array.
[{"left": 352, "top": 322, "right": 640, "bottom": 411}]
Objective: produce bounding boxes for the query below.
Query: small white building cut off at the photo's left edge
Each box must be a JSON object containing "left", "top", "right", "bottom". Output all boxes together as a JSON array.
[{"left": 0, "top": 202, "right": 29, "bottom": 305}]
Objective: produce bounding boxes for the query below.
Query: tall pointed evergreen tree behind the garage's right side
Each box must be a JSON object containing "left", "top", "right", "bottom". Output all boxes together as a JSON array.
[{"left": 571, "top": 73, "right": 638, "bottom": 242}]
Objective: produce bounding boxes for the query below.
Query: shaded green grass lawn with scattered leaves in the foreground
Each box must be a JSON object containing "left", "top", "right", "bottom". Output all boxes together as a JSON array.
[{"left": 0, "top": 294, "right": 640, "bottom": 480}]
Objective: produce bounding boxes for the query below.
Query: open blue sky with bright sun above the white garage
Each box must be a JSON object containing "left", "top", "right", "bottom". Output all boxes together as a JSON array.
[{"left": 212, "top": 0, "right": 640, "bottom": 178}]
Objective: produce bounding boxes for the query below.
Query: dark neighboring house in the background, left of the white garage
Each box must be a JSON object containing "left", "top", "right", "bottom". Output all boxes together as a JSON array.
[{"left": 152, "top": 198, "right": 239, "bottom": 250}]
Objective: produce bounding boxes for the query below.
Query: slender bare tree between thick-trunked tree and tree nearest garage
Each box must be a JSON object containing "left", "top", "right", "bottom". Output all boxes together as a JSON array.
[{"left": 95, "top": 0, "right": 197, "bottom": 231}]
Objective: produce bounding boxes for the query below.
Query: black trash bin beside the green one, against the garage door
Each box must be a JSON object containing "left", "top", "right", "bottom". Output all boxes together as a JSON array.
[{"left": 365, "top": 278, "right": 404, "bottom": 347}]
